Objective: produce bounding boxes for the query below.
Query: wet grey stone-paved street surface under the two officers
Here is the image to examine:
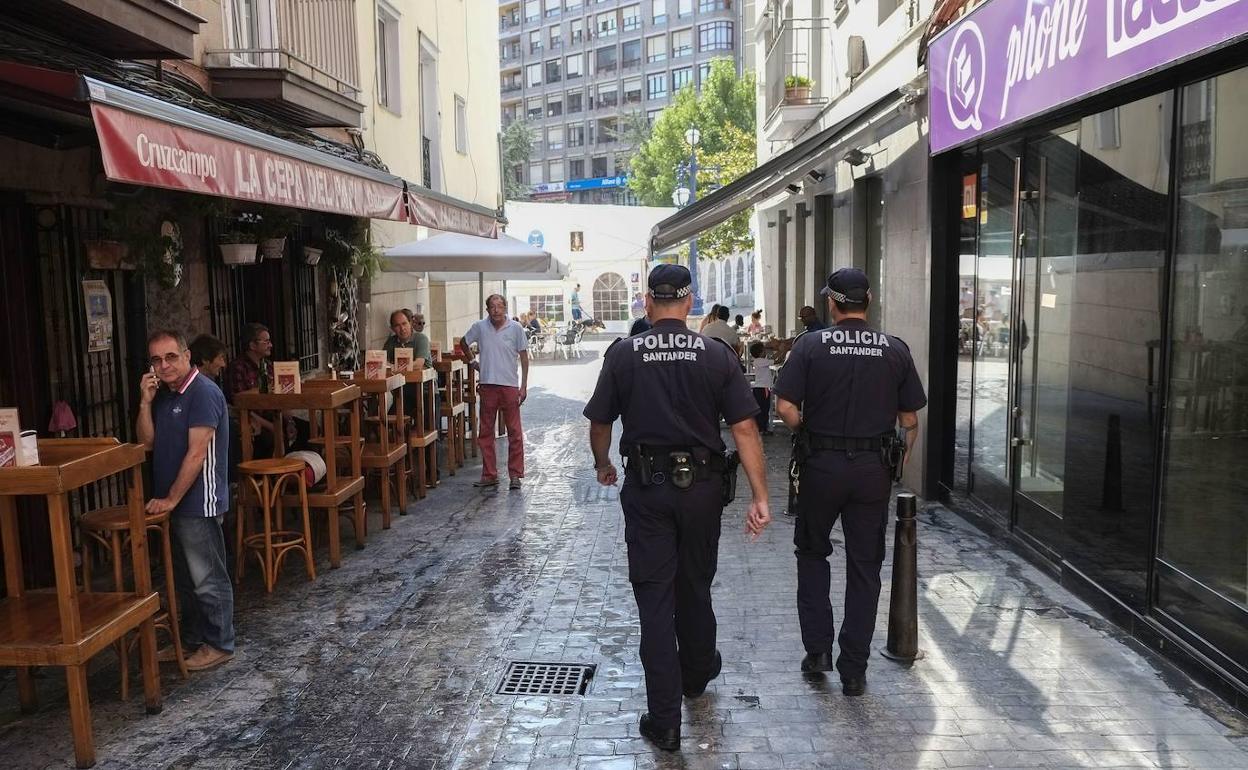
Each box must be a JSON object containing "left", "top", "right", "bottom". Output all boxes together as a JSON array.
[{"left": 0, "top": 346, "right": 1248, "bottom": 770}]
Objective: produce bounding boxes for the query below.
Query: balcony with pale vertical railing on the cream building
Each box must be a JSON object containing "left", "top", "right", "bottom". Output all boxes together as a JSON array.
[{"left": 205, "top": 0, "right": 364, "bottom": 127}]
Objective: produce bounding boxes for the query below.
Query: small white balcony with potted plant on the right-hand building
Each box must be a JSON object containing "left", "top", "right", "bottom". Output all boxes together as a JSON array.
[{"left": 763, "top": 19, "right": 829, "bottom": 141}]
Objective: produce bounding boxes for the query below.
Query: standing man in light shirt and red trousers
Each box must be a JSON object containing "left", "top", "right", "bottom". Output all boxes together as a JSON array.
[{"left": 463, "top": 295, "right": 529, "bottom": 489}]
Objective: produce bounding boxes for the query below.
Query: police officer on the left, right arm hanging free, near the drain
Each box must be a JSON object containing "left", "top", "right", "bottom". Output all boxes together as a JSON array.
[{"left": 584, "top": 265, "right": 771, "bottom": 751}]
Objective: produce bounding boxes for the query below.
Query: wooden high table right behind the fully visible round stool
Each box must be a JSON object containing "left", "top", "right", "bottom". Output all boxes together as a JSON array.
[{"left": 235, "top": 379, "right": 364, "bottom": 569}]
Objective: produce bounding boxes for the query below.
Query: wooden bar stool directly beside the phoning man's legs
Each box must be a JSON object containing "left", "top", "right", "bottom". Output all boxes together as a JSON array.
[{"left": 79, "top": 505, "right": 190, "bottom": 700}]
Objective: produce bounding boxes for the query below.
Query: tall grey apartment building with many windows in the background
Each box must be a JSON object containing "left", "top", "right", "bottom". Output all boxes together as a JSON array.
[{"left": 498, "top": 0, "right": 753, "bottom": 205}]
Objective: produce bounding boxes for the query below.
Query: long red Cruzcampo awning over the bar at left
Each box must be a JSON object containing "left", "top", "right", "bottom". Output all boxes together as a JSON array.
[{"left": 0, "top": 60, "right": 498, "bottom": 230}]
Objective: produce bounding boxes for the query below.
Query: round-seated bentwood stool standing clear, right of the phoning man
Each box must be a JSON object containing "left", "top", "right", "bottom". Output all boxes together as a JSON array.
[{"left": 235, "top": 458, "right": 316, "bottom": 593}]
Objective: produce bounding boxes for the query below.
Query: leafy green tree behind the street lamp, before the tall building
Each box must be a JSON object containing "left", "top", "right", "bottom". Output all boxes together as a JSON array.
[{"left": 629, "top": 59, "right": 756, "bottom": 258}]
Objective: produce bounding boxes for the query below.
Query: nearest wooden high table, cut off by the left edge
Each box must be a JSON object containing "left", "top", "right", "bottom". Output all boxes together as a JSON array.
[{"left": 0, "top": 438, "right": 161, "bottom": 768}]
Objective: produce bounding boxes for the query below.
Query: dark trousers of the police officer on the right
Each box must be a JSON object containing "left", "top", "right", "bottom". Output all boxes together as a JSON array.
[{"left": 792, "top": 449, "right": 892, "bottom": 676}]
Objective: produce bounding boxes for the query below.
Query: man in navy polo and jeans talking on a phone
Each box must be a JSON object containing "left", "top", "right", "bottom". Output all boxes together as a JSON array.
[{"left": 136, "top": 331, "right": 235, "bottom": 671}]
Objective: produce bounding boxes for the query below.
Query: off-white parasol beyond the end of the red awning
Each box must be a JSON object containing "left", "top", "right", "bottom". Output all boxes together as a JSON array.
[{"left": 383, "top": 232, "right": 558, "bottom": 274}]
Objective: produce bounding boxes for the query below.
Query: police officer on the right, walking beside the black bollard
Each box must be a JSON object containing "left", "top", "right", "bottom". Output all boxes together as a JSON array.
[{"left": 775, "top": 267, "right": 927, "bottom": 695}]
